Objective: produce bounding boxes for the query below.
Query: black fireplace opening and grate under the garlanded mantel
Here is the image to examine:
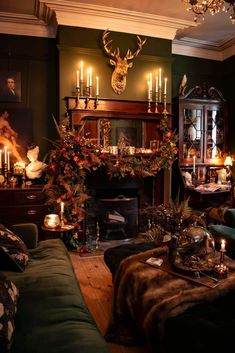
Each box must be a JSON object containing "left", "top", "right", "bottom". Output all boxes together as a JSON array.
[{"left": 86, "top": 172, "right": 163, "bottom": 240}]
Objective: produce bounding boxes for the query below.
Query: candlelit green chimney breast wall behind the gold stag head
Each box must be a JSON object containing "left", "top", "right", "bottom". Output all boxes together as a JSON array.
[{"left": 58, "top": 26, "right": 171, "bottom": 116}]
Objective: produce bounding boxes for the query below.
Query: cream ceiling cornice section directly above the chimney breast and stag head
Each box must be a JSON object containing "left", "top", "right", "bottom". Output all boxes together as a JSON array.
[{"left": 40, "top": 0, "right": 196, "bottom": 40}]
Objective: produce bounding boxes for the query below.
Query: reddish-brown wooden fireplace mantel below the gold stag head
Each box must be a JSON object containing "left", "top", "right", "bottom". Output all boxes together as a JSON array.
[{"left": 64, "top": 96, "right": 172, "bottom": 204}]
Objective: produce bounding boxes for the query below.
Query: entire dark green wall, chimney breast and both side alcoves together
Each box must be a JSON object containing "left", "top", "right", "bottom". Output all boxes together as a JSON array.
[{"left": 0, "top": 26, "right": 235, "bottom": 160}]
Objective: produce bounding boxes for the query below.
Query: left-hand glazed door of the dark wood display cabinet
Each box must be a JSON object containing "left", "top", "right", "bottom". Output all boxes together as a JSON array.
[{"left": 182, "top": 108, "right": 203, "bottom": 162}]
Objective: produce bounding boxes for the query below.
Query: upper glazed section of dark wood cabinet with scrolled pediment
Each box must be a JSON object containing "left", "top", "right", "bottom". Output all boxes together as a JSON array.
[{"left": 172, "top": 86, "right": 227, "bottom": 166}]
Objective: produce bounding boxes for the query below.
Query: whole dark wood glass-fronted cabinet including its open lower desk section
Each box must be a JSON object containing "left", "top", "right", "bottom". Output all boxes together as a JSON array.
[{"left": 172, "top": 86, "right": 229, "bottom": 208}]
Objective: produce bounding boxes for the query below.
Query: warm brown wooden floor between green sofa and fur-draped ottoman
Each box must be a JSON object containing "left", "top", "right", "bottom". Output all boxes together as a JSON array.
[{"left": 70, "top": 244, "right": 149, "bottom": 353}]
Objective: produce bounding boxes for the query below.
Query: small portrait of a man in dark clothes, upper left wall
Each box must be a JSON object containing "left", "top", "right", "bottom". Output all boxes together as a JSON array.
[{"left": 0, "top": 71, "right": 21, "bottom": 103}]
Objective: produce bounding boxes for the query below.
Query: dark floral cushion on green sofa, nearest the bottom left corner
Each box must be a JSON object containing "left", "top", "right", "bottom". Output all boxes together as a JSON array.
[{"left": 0, "top": 273, "right": 19, "bottom": 353}]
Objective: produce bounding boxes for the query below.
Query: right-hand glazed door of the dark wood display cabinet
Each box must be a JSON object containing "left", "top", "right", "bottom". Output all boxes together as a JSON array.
[{"left": 205, "top": 109, "right": 224, "bottom": 163}]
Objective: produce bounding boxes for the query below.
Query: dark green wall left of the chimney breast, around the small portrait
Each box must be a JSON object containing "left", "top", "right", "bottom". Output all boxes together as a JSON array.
[{"left": 0, "top": 34, "right": 58, "bottom": 158}]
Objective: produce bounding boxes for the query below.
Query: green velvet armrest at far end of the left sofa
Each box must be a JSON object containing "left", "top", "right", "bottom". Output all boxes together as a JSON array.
[{"left": 12, "top": 223, "right": 38, "bottom": 249}]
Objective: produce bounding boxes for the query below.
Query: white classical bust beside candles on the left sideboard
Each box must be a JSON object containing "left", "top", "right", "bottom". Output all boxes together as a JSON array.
[{"left": 25, "top": 144, "right": 47, "bottom": 179}]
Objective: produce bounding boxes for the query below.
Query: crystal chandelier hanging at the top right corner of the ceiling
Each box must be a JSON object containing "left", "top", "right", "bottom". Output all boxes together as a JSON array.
[{"left": 184, "top": 0, "right": 235, "bottom": 24}]
